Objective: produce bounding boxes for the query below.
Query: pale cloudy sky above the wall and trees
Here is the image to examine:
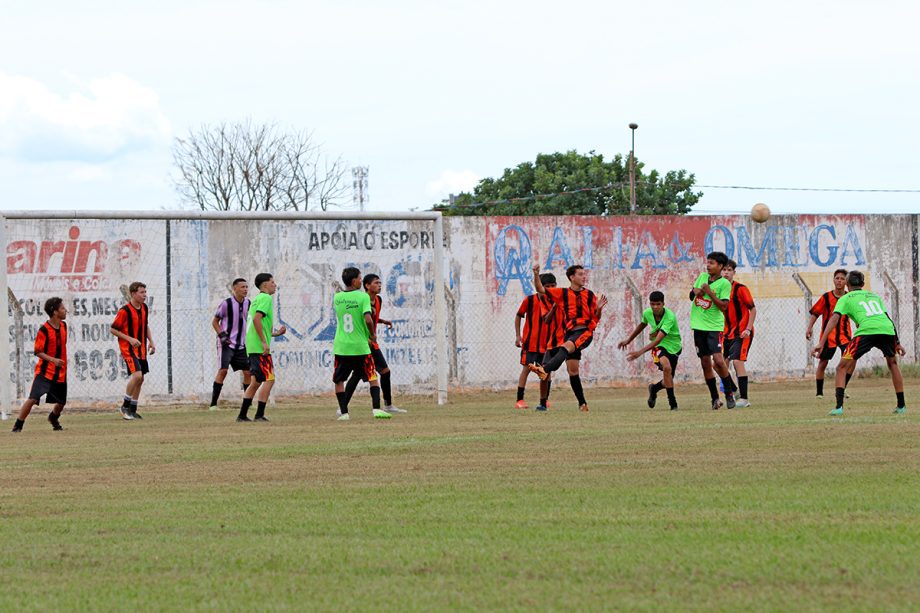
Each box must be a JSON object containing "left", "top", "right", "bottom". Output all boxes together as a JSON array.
[{"left": 0, "top": 0, "right": 920, "bottom": 213}]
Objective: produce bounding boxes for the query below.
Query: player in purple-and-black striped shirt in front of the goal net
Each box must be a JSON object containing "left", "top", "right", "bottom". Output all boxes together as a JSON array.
[{"left": 210, "top": 279, "right": 251, "bottom": 411}]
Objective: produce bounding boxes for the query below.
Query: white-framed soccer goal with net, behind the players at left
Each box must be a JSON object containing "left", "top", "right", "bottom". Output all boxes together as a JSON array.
[{"left": 0, "top": 211, "right": 449, "bottom": 418}]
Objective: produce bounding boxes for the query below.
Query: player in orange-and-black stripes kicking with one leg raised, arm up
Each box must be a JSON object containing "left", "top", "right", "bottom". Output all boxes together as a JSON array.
[{"left": 529, "top": 264, "right": 607, "bottom": 413}]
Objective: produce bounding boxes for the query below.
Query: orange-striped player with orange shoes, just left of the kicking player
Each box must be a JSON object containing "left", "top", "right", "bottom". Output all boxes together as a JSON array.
[{"left": 514, "top": 273, "right": 556, "bottom": 410}]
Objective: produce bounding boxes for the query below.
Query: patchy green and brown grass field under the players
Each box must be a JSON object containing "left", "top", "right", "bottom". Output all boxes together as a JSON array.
[{"left": 0, "top": 379, "right": 920, "bottom": 610}]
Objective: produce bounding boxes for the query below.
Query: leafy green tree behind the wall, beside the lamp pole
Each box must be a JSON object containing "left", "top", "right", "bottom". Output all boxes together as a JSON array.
[{"left": 434, "top": 151, "right": 703, "bottom": 215}]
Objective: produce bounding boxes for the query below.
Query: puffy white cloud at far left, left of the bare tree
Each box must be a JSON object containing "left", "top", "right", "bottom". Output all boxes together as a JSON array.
[{"left": 0, "top": 72, "right": 171, "bottom": 162}]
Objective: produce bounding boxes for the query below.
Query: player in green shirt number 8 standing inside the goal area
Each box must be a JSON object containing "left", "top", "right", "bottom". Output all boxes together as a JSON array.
[{"left": 332, "top": 267, "right": 390, "bottom": 421}]
